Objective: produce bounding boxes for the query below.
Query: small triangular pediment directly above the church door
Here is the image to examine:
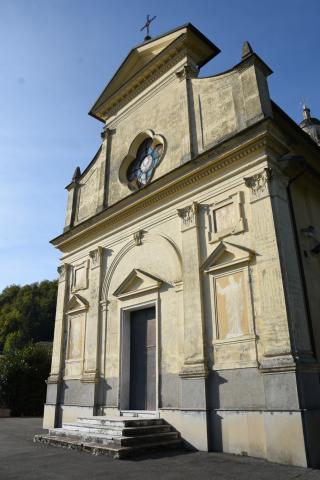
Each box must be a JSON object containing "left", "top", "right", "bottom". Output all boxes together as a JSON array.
[{"left": 114, "top": 268, "right": 163, "bottom": 298}]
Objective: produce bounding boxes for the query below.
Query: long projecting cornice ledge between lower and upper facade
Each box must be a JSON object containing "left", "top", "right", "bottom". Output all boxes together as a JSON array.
[{"left": 51, "top": 119, "right": 285, "bottom": 251}]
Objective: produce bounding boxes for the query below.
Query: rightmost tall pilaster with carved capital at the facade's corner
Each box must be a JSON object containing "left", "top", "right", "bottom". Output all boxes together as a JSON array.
[{"left": 245, "top": 167, "right": 310, "bottom": 371}]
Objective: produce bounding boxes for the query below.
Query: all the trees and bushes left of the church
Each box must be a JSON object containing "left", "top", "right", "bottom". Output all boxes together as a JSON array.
[{"left": 0, "top": 280, "right": 57, "bottom": 415}]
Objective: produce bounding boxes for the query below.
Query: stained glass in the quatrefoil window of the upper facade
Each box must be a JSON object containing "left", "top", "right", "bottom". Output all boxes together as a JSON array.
[{"left": 127, "top": 138, "right": 163, "bottom": 188}]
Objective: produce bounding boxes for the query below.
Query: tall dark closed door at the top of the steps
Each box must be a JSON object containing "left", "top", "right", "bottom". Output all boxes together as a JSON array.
[{"left": 130, "top": 307, "right": 156, "bottom": 410}]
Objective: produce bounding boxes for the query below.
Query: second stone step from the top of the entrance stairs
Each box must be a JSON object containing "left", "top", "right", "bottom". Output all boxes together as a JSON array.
[{"left": 62, "top": 422, "right": 171, "bottom": 437}]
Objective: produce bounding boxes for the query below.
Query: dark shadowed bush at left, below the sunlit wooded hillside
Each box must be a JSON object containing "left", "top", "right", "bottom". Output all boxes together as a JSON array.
[{"left": 0, "top": 344, "right": 51, "bottom": 416}]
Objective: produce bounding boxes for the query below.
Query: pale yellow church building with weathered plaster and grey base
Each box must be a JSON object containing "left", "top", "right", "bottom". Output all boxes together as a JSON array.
[{"left": 44, "top": 24, "right": 320, "bottom": 466}]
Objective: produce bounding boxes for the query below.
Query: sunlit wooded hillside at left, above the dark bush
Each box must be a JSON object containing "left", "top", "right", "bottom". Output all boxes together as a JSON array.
[{"left": 0, "top": 280, "right": 57, "bottom": 351}]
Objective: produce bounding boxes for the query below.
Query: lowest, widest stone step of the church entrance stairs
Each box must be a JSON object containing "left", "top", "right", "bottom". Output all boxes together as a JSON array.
[{"left": 34, "top": 434, "right": 181, "bottom": 459}]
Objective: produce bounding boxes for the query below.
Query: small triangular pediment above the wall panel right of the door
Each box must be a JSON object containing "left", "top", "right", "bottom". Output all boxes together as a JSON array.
[{"left": 202, "top": 242, "right": 255, "bottom": 273}]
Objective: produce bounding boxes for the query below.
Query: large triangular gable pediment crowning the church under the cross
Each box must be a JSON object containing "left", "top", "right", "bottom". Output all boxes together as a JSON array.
[{"left": 89, "top": 23, "right": 220, "bottom": 121}]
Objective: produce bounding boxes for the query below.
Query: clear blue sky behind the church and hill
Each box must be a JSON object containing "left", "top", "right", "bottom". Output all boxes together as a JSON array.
[{"left": 0, "top": 0, "right": 320, "bottom": 290}]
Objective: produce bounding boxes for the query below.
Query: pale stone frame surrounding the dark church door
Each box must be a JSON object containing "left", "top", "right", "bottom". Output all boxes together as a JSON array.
[{"left": 118, "top": 292, "right": 160, "bottom": 412}]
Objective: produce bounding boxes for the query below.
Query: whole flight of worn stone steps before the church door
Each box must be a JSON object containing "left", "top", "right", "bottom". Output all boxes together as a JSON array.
[{"left": 34, "top": 416, "right": 182, "bottom": 458}]
